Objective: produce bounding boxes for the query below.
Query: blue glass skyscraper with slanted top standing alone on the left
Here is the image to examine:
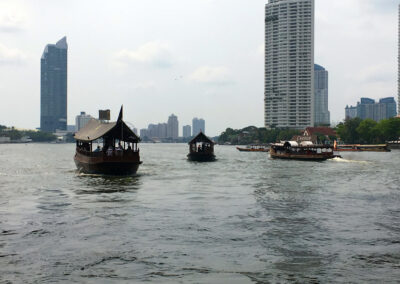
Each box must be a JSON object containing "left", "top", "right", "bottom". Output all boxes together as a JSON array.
[{"left": 40, "top": 37, "right": 68, "bottom": 132}]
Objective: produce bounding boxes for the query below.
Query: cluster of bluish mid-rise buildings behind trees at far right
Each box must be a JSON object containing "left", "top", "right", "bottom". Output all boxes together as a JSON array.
[{"left": 345, "top": 97, "right": 397, "bottom": 121}]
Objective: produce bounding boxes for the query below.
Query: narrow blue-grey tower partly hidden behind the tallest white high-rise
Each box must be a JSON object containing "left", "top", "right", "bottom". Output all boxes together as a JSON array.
[{"left": 314, "top": 64, "right": 331, "bottom": 125}]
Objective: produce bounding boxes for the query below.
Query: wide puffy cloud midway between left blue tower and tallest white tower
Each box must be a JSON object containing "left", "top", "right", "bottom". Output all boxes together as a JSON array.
[{"left": 114, "top": 41, "right": 173, "bottom": 68}]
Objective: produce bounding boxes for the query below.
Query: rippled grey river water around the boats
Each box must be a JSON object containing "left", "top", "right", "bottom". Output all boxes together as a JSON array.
[{"left": 0, "top": 144, "right": 400, "bottom": 283}]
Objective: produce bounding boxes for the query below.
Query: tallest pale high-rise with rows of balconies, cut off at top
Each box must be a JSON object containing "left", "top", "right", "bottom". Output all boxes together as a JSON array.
[{"left": 264, "top": 0, "right": 314, "bottom": 129}]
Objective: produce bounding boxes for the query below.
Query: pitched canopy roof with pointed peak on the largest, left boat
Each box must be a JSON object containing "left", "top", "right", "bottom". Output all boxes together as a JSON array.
[{"left": 74, "top": 107, "right": 140, "bottom": 143}]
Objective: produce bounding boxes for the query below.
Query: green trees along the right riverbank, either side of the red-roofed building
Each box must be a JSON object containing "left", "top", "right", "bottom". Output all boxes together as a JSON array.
[{"left": 218, "top": 118, "right": 400, "bottom": 145}]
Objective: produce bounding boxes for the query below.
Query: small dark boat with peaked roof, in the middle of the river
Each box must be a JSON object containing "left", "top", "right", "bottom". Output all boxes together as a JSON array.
[{"left": 187, "top": 132, "right": 215, "bottom": 162}]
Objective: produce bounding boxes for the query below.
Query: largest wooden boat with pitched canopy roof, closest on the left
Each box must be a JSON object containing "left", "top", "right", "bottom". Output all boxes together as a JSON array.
[{"left": 74, "top": 107, "right": 142, "bottom": 175}]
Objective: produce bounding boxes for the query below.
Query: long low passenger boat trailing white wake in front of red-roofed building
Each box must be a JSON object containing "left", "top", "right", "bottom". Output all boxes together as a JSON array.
[{"left": 269, "top": 141, "right": 340, "bottom": 161}]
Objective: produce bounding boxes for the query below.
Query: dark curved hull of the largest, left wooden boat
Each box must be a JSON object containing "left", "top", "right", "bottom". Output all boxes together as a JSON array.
[{"left": 74, "top": 153, "right": 142, "bottom": 175}]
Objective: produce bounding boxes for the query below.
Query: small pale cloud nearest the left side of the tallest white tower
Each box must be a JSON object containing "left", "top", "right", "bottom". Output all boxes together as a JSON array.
[{"left": 189, "top": 66, "right": 233, "bottom": 85}]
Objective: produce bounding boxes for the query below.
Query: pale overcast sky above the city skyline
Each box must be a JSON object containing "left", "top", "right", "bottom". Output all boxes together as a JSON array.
[{"left": 0, "top": 0, "right": 399, "bottom": 136}]
